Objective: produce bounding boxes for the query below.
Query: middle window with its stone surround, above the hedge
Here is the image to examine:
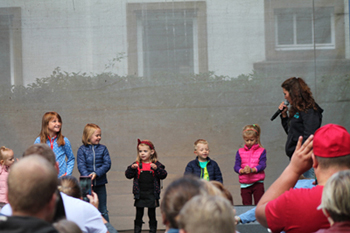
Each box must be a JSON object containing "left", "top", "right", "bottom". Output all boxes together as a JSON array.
[{"left": 127, "top": 2, "right": 208, "bottom": 77}]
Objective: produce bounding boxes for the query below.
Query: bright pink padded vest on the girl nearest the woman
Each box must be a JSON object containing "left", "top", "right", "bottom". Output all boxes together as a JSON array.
[{"left": 238, "top": 144, "right": 265, "bottom": 184}]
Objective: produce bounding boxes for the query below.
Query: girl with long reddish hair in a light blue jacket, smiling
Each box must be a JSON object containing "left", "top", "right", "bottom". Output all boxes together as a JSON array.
[{"left": 34, "top": 112, "right": 75, "bottom": 177}]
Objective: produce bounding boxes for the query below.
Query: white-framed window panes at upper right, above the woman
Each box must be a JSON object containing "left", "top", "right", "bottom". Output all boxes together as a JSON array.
[{"left": 274, "top": 7, "right": 335, "bottom": 50}]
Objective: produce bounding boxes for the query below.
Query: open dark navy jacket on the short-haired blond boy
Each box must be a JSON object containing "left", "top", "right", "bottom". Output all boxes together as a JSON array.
[{"left": 185, "top": 156, "right": 223, "bottom": 183}]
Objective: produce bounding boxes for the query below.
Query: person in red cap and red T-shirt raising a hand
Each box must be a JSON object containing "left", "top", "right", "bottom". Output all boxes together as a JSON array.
[{"left": 255, "top": 124, "right": 350, "bottom": 233}]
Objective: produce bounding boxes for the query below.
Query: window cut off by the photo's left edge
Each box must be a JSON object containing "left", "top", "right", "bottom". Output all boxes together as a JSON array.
[{"left": 0, "top": 7, "right": 23, "bottom": 87}]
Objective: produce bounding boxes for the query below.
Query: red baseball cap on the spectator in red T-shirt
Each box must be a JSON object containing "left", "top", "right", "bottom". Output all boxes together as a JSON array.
[{"left": 313, "top": 124, "right": 350, "bottom": 158}]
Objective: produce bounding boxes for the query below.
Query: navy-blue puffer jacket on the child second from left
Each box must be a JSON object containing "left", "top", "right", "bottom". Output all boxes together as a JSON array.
[{"left": 77, "top": 144, "right": 112, "bottom": 186}]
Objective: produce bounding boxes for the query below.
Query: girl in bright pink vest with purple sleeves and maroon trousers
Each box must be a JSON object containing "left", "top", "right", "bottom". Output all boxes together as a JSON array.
[{"left": 234, "top": 124, "right": 266, "bottom": 205}]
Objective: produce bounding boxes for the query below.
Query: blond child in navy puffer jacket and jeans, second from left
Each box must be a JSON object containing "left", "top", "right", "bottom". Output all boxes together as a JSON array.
[{"left": 77, "top": 124, "right": 111, "bottom": 222}]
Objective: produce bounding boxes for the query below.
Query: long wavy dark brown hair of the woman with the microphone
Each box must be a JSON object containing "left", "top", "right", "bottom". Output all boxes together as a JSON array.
[{"left": 281, "top": 77, "right": 317, "bottom": 118}]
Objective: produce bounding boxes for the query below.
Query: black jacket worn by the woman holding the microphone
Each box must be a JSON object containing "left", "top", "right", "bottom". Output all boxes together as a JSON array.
[{"left": 281, "top": 104, "right": 323, "bottom": 158}]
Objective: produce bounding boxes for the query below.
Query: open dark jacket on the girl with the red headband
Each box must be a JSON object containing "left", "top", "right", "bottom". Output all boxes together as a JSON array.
[{"left": 125, "top": 161, "right": 168, "bottom": 200}]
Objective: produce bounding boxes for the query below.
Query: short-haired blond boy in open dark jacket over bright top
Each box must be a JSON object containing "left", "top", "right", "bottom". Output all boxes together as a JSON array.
[{"left": 185, "top": 139, "right": 223, "bottom": 183}]
